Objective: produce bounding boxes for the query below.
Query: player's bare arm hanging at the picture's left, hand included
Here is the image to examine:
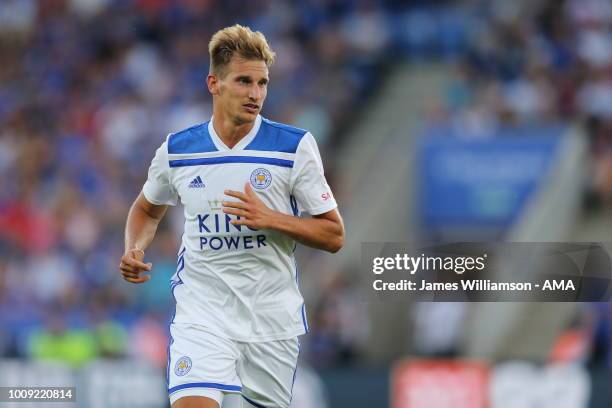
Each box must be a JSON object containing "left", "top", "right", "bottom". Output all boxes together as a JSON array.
[{"left": 119, "top": 192, "right": 168, "bottom": 283}]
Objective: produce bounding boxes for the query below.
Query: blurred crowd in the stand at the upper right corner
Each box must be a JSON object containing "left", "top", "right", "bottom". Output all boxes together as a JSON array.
[{"left": 429, "top": 0, "right": 612, "bottom": 205}]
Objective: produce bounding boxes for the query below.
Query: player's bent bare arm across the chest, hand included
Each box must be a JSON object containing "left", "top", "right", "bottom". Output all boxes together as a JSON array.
[{"left": 223, "top": 183, "right": 344, "bottom": 253}]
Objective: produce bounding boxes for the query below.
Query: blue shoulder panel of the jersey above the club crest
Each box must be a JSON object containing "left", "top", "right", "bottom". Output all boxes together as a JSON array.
[{"left": 244, "top": 118, "right": 307, "bottom": 153}]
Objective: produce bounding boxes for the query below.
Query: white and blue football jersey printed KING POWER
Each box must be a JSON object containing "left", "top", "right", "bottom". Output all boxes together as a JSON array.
[{"left": 143, "top": 116, "right": 336, "bottom": 341}]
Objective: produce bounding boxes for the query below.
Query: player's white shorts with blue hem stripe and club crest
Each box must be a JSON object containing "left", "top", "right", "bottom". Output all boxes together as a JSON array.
[{"left": 167, "top": 323, "right": 300, "bottom": 408}]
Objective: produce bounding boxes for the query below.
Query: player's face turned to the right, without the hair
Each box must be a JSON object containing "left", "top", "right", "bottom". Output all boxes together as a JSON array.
[{"left": 208, "top": 56, "right": 269, "bottom": 125}]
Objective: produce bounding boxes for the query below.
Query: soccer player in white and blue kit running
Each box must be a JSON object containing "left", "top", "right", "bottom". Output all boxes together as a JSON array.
[{"left": 120, "top": 25, "right": 344, "bottom": 408}]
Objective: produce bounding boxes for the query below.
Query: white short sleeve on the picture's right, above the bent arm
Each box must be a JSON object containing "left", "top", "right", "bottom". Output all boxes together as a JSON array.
[{"left": 291, "top": 133, "right": 337, "bottom": 215}]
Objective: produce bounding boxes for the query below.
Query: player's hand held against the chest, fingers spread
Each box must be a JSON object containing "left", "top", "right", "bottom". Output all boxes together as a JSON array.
[{"left": 222, "top": 183, "right": 274, "bottom": 230}]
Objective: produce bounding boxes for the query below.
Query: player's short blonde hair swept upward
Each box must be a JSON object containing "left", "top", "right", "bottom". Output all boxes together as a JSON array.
[{"left": 208, "top": 24, "right": 276, "bottom": 77}]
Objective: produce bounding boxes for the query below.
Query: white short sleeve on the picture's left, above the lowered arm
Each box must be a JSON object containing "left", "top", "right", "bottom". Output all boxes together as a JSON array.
[{"left": 142, "top": 141, "right": 178, "bottom": 205}]
